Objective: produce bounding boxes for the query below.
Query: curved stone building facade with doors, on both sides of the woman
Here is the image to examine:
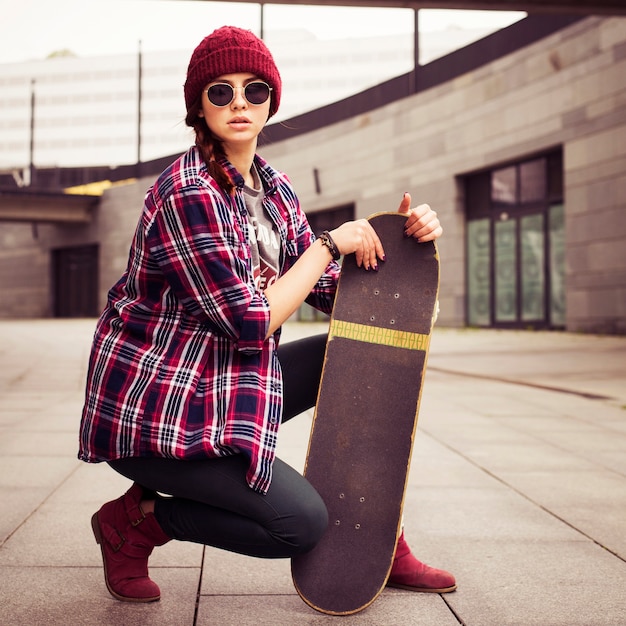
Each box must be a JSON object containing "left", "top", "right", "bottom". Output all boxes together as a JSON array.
[{"left": 0, "top": 17, "right": 626, "bottom": 334}]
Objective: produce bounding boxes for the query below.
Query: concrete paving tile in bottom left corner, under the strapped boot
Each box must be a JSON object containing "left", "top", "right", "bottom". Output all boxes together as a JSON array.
[{"left": 0, "top": 567, "right": 200, "bottom": 626}]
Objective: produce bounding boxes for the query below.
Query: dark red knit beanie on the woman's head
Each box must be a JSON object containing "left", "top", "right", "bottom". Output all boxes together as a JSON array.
[{"left": 185, "top": 26, "right": 282, "bottom": 117}]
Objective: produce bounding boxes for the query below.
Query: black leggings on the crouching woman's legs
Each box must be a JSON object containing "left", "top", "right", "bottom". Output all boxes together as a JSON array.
[{"left": 109, "top": 335, "right": 328, "bottom": 558}]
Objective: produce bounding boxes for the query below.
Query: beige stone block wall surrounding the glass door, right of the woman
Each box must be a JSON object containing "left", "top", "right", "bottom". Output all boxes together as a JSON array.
[{"left": 262, "top": 17, "right": 626, "bottom": 332}]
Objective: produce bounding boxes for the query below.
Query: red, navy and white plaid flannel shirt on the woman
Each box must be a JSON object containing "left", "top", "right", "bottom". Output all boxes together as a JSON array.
[{"left": 78, "top": 147, "right": 339, "bottom": 493}]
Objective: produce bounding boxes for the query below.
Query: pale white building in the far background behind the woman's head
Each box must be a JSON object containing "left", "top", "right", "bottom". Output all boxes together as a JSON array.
[{"left": 0, "top": 14, "right": 512, "bottom": 168}]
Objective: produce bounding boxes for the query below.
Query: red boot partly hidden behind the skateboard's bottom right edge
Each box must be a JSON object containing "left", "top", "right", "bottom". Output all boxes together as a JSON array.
[{"left": 387, "top": 531, "right": 456, "bottom": 593}]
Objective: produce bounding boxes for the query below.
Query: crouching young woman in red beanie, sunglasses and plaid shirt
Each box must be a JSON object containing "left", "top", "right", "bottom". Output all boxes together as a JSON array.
[{"left": 79, "top": 27, "right": 455, "bottom": 602}]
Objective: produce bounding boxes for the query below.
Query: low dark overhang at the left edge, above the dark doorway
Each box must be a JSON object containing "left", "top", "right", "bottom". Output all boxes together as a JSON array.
[{"left": 0, "top": 189, "right": 100, "bottom": 224}]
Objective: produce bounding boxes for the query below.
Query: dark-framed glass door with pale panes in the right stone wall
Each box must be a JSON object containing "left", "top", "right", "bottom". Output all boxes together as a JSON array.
[{"left": 465, "top": 153, "right": 565, "bottom": 328}]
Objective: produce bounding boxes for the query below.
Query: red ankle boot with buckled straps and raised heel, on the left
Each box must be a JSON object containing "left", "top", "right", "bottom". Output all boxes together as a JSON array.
[{"left": 91, "top": 483, "right": 170, "bottom": 602}]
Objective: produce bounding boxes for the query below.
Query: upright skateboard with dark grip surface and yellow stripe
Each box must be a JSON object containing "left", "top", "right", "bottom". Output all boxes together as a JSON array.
[{"left": 291, "top": 213, "right": 439, "bottom": 615}]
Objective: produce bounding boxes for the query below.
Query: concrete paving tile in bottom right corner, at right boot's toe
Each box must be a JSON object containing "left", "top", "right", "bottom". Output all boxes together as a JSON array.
[{"left": 446, "top": 541, "right": 626, "bottom": 626}]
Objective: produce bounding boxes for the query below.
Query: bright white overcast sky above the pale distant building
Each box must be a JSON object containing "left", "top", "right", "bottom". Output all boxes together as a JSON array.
[{"left": 0, "top": 0, "right": 523, "bottom": 63}]
